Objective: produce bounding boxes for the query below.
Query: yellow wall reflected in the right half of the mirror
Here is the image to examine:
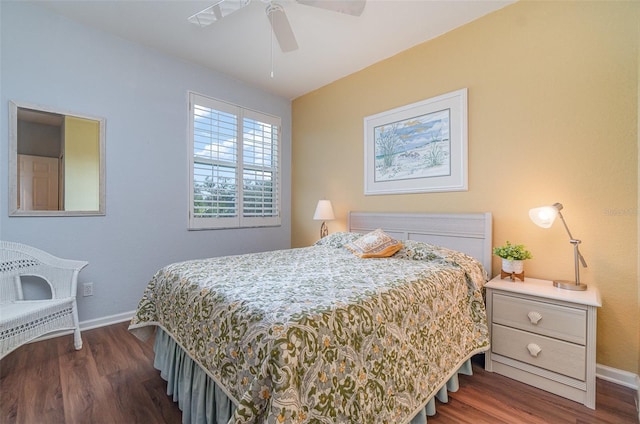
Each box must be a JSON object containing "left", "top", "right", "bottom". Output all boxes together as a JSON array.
[{"left": 64, "top": 116, "right": 100, "bottom": 211}]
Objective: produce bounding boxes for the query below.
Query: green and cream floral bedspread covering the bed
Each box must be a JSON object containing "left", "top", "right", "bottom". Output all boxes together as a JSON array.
[{"left": 130, "top": 233, "right": 489, "bottom": 424}]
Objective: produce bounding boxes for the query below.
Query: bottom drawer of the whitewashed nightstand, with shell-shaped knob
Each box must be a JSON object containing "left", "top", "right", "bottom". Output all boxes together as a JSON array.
[{"left": 491, "top": 324, "right": 586, "bottom": 381}]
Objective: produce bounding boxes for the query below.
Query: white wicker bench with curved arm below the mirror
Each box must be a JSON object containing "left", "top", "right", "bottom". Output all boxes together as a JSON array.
[{"left": 0, "top": 241, "right": 88, "bottom": 359}]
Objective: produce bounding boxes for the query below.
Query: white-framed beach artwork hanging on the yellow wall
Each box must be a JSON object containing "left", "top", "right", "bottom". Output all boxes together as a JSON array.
[{"left": 364, "top": 88, "right": 468, "bottom": 195}]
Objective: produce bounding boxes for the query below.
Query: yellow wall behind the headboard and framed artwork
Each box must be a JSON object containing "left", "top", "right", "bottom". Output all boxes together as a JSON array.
[{"left": 292, "top": 1, "right": 640, "bottom": 373}]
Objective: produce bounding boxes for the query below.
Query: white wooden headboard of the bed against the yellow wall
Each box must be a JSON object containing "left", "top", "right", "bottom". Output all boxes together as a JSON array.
[{"left": 347, "top": 212, "right": 492, "bottom": 277}]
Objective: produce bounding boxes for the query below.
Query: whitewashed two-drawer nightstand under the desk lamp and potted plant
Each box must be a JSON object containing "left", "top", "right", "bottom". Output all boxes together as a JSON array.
[{"left": 485, "top": 276, "right": 602, "bottom": 409}]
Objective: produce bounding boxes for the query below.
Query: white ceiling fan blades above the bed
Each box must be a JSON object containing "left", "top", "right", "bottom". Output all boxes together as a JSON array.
[{"left": 188, "top": 0, "right": 367, "bottom": 53}]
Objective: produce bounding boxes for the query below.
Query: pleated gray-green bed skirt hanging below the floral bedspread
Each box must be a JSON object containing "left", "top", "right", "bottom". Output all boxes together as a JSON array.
[{"left": 153, "top": 327, "right": 473, "bottom": 424}]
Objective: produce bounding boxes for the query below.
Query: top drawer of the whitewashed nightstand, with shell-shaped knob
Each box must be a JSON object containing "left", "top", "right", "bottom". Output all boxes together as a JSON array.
[{"left": 492, "top": 293, "right": 587, "bottom": 345}]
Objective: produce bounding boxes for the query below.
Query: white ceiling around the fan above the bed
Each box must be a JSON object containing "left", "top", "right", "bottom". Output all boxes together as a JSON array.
[{"left": 35, "top": 0, "right": 515, "bottom": 99}]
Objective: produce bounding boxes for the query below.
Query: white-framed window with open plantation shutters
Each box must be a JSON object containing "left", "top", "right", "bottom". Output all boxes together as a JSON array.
[{"left": 189, "top": 93, "right": 280, "bottom": 229}]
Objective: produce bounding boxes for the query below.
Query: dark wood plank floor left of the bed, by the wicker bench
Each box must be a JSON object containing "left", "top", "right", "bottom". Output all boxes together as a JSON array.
[{"left": 0, "top": 323, "right": 182, "bottom": 424}]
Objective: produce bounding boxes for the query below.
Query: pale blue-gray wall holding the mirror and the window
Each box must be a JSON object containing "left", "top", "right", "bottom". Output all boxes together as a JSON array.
[{"left": 0, "top": 2, "right": 291, "bottom": 321}]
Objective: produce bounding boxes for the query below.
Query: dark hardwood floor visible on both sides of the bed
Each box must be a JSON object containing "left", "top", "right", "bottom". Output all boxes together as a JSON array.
[{"left": 0, "top": 323, "right": 638, "bottom": 424}]
